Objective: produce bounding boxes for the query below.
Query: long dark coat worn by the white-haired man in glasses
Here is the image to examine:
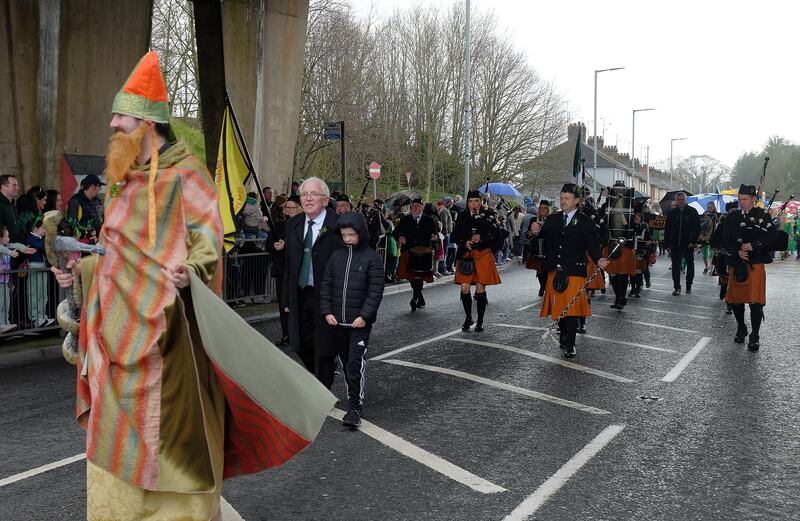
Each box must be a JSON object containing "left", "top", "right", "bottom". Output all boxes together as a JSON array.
[{"left": 281, "top": 210, "right": 344, "bottom": 356}]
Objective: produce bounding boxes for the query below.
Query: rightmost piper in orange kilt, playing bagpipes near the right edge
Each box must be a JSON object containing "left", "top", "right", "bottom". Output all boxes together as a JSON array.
[{"left": 722, "top": 184, "right": 778, "bottom": 351}]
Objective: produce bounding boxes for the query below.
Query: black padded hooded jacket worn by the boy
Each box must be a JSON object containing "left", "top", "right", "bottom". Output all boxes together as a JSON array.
[{"left": 319, "top": 212, "right": 384, "bottom": 324}]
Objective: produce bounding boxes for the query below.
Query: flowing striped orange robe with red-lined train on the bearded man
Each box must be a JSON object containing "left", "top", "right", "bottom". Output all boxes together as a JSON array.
[{"left": 77, "top": 142, "right": 334, "bottom": 508}]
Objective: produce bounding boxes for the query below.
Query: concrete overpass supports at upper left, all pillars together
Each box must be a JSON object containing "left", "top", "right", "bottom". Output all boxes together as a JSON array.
[{"left": 0, "top": 0, "right": 308, "bottom": 193}]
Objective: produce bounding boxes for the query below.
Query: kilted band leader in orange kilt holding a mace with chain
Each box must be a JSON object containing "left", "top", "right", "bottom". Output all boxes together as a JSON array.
[{"left": 531, "top": 183, "right": 608, "bottom": 358}]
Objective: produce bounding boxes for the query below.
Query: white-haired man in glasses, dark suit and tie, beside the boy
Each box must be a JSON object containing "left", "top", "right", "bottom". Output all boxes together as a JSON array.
[{"left": 281, "top": 177, "right": 344, "bottom": 389}]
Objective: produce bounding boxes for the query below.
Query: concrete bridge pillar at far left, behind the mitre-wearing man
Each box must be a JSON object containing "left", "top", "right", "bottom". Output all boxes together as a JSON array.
[{"left": 0, "top": 0, "right": 152, "bottom": 188}]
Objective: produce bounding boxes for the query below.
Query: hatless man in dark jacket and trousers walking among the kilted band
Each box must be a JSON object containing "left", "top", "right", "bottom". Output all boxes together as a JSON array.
[{"left": 664, "top": 192, "right": 700, "bottom": 296}]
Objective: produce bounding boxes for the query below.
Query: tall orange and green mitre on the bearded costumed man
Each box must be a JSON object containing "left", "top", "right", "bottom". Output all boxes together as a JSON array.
[{"left": 111, "top": 51, "right": 170, "bottom": 124}]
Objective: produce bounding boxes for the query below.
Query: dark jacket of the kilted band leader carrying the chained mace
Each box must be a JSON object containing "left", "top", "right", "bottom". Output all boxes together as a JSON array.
[{"left": 539, "top": 210, "right": 602, "bottom": 277}]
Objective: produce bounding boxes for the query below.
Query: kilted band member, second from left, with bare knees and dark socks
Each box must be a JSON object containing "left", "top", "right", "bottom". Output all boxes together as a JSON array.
[{"left": 451, "top": 190, "right": 500, "bottom": 332}]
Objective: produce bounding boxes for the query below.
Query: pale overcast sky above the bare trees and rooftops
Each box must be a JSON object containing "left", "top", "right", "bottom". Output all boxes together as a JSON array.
[{"left": 350, "top": 0, "right": 800, "bottom": 167}]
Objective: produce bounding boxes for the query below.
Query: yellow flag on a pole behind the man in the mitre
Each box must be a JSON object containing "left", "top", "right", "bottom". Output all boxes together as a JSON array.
[{"left": 214, "top": 107, "right": 250, "bottom": 251}]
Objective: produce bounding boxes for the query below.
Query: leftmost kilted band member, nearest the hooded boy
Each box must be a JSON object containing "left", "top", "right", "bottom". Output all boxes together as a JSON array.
[{"left": 392, "top": 197, "right": 439, "bottom": 312}]
